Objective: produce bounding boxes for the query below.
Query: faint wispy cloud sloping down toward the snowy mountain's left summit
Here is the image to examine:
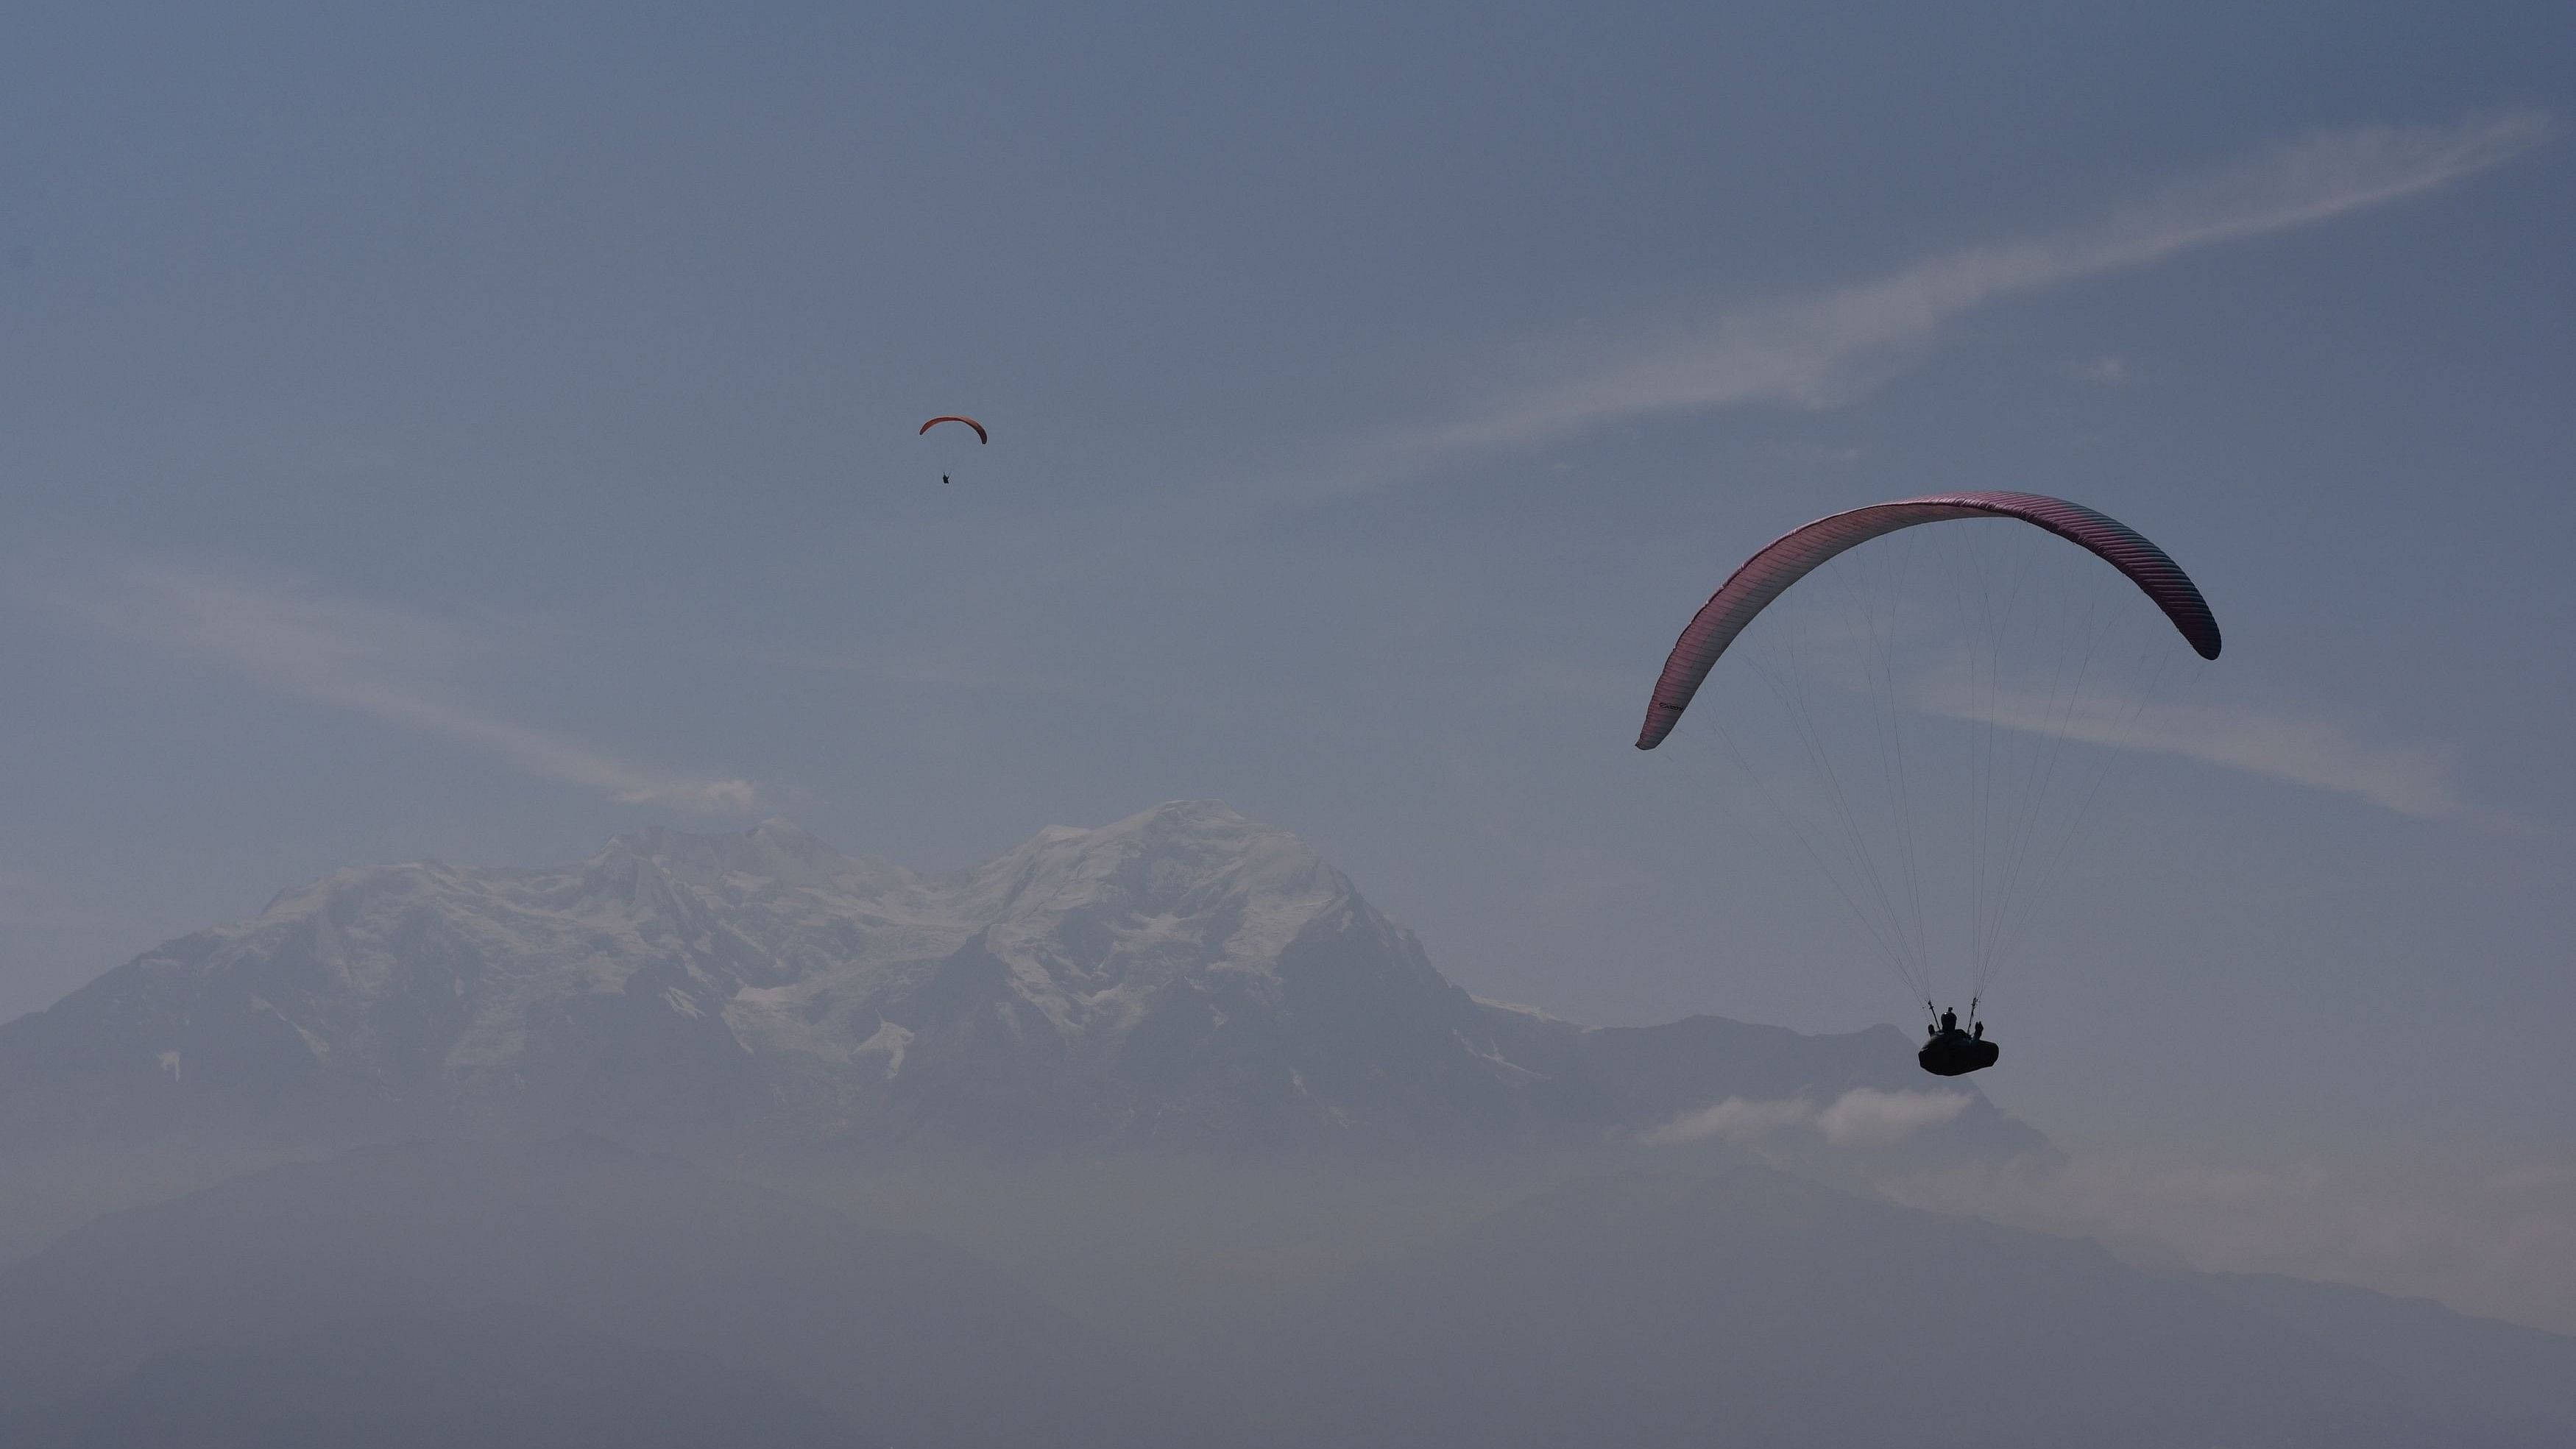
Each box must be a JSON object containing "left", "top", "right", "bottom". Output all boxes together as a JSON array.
[{"left": 21, "top": 561, "right": 760, "bottom": 816}]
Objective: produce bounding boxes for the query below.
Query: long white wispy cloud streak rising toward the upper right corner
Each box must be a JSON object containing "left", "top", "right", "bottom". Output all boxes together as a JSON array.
[{"left": 1363, "top": 110, "right": 2550, "bottom": 479}]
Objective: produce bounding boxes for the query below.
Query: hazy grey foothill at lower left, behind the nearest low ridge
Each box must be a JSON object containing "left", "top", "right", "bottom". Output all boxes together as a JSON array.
[{"left": 0, "top": 1135, "right": 1164, "bottom": 1444}]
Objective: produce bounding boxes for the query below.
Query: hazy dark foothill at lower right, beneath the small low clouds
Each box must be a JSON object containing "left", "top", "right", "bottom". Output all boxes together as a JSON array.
[{"left": 1164, "top": 1163, "right": 2576, "bottom": 1449}]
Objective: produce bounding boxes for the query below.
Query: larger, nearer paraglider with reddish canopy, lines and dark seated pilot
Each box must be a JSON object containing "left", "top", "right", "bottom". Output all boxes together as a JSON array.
[{"left": 1636, "top": 492, "right": 2221, "bottom": 1076}]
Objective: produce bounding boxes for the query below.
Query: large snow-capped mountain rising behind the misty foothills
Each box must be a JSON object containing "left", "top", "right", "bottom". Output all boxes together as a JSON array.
[{"left": 0, "top": 801, "right": 2038, "bottom": 1148}]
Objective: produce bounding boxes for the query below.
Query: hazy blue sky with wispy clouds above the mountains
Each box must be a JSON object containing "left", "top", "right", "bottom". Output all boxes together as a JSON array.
[{"left": 0, "top": 2, "right": 2576, "bottom": 1161}]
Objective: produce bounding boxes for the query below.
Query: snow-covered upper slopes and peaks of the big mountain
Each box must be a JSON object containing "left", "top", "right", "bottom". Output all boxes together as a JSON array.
[{"left": 4, "top": 803, "right": 1365, "bottom": 1111}]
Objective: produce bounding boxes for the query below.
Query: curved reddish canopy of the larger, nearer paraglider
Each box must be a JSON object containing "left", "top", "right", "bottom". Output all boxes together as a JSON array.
[{"left": 1636, "top": 492, "right": 2218, "bottom": 749}]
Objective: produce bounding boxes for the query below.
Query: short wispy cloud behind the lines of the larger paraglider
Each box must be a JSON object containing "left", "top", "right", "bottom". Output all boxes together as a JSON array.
[{"left": 1909, "top": 684, "right": 2527, "bottom": 829}]
